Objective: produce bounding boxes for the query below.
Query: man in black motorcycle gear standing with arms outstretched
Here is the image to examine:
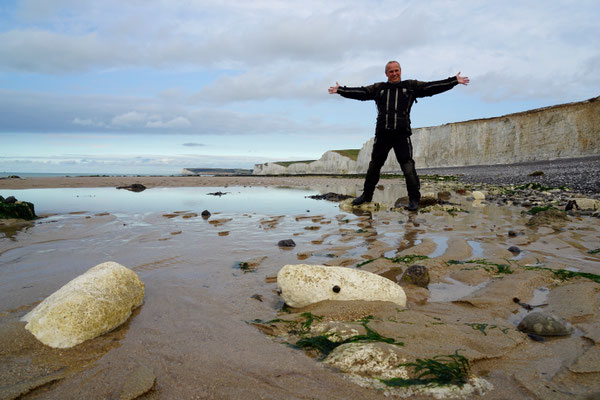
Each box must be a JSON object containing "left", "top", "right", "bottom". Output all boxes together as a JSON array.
[{"left": 329, "top": 61, "right": 469, "bottom": 211}]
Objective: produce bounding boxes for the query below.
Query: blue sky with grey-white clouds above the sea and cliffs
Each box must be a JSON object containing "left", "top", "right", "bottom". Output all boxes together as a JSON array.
[{"left": 0, "top": 0, "right": 600, "bottom": 174}]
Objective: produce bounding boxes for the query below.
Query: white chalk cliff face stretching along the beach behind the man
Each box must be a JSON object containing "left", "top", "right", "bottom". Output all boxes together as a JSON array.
[{"left": 254, "top": 97, "right": 600, "bottom": 175}]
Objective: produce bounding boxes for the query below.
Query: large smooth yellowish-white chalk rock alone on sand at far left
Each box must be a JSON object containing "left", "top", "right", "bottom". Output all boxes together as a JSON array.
[{"left": 22, "top": 262, "right": 144, "bottom": 348}]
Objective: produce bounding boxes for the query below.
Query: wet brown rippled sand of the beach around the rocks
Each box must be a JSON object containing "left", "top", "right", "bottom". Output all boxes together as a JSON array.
[{"left": 0, "top": 177, "right": 600, "bottom": 399}]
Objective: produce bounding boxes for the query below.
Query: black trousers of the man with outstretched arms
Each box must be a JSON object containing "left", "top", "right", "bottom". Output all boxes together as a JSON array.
[{"left": 363, "top": 130, "right": 421, "bottom": 199}]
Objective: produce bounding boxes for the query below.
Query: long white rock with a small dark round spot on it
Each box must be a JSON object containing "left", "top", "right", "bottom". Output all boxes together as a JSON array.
[{"left": 277, "top": 264, "right": 406, "bottom": 308}]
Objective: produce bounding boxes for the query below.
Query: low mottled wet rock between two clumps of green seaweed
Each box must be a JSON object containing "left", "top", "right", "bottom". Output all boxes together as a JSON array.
[{"left": 323, "top": 343, "right": 408, "bottom": 379}]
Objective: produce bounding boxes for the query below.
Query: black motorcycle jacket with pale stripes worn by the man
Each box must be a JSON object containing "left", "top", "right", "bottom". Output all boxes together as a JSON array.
[{"left": 337, "top": 76, "right": 458, "bottom": 135}]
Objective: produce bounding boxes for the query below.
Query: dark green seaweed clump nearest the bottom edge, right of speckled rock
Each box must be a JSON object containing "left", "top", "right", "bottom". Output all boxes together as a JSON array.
[{"left": 381, "top": 350, "right": 470, "bottom": 387}]
